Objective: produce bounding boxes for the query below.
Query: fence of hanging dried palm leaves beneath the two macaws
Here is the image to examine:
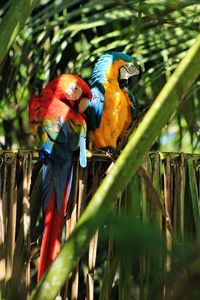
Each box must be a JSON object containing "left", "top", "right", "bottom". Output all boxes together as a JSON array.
[{"left": 0, "top": 151, "right": 200, "bottom": 300}]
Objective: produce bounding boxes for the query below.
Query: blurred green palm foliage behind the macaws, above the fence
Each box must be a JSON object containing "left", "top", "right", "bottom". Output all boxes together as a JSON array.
[{"left": 0, "top": 0, "right": 200, "bottom": 152}]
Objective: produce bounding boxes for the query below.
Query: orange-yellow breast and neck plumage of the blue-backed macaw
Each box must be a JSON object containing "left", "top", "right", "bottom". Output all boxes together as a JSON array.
[{"left": 94, "top": 60, "right": 132, "bottom": 148}]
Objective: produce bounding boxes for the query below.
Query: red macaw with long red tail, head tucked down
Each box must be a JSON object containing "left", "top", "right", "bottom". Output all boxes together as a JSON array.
[{"left": 29, "top": 74, "right": 92, "bottom": 281}]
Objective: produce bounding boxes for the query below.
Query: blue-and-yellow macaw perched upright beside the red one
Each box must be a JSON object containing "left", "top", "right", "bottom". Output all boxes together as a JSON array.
[{"left": 85, "top": 52, "right": 140, "bottom": 149}]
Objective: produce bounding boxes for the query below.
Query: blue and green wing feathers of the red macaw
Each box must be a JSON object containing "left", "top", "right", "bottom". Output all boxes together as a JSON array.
[{"left": 37, "top": 118, "right": 86, "bottom": 210}]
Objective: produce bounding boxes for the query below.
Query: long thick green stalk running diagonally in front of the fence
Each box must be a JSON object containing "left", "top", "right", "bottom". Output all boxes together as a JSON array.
[{"left": 31, "top": 36, "right": 200, "bottom": 300}]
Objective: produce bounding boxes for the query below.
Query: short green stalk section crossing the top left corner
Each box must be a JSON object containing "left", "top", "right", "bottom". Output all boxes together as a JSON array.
[{"left": 0, "top": 0, "right": 39, "bottom": 63}]
